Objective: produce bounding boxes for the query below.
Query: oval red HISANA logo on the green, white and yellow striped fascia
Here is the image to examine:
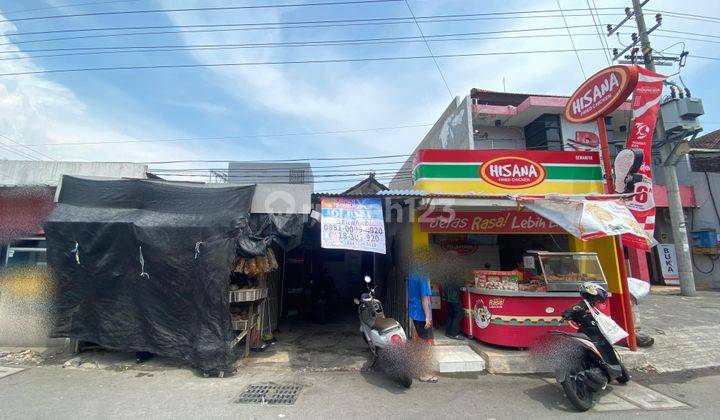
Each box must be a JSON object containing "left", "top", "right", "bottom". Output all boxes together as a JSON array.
[{"left": 480, "top": 156, "right": 546, "bottom": 189}]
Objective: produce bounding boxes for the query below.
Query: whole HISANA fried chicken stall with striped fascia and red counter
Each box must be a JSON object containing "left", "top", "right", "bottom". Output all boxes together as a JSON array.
[{"left": 404, "top": 150, "right": 645, "bottom": 348}]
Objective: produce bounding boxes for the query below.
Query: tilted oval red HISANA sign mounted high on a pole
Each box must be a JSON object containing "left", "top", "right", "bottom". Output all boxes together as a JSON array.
[{"left": 565, "top": 66, "right": 638, "bottom": 123}]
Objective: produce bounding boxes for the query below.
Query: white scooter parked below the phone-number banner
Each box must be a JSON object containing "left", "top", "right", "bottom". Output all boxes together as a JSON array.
[{"left": 355, "top": 276, "right": 413, "bottom": 388}]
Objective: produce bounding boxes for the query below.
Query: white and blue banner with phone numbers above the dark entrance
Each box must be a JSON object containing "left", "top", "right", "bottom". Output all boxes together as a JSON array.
[{"left": 320, "top": 197, "right": 385, "bottom": 254}]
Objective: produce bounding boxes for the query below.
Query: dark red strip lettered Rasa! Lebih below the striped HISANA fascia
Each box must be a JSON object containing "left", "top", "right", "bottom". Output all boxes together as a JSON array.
[{"left": 420, "top": 210, "right": 567, "bottom": 234}]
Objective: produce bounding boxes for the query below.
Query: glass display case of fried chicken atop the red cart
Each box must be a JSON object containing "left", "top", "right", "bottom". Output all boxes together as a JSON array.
[{"left": 528, "top": 251, "right": 607, "bottom": 292}]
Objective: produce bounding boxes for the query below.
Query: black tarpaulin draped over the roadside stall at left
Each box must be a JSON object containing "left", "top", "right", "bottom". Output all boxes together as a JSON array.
[{"left": 45, "top": 176, "right": 304, "bottom": 371}]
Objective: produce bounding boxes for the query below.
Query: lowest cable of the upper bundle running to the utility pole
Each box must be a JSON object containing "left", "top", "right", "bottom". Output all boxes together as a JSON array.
[{"left": 0, "top": 48, "right": 602, "bottom": 77}]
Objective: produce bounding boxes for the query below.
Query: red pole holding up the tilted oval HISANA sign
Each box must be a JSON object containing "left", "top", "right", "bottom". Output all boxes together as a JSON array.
[{"left": 597, "top": 117, "right": 637, "bottom": 351}]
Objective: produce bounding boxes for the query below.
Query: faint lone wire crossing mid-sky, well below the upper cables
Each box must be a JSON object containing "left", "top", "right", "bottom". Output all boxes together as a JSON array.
[{"left": 2, "top": 124, "right": 433, "bottom": 148}]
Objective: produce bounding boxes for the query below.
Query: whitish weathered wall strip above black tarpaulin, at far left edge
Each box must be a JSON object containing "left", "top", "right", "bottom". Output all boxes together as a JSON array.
[{"left": 0, "top": 160, "right": 148, "bottom": 186}]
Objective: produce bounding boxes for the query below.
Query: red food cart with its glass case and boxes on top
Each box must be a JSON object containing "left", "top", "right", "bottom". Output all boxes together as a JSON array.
[{"left": 461, "top": 251, "right": 610, "bottom": 348}]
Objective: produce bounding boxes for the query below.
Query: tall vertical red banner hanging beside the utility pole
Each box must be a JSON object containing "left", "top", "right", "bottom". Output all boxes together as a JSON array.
[{"left": 622, "top": 67, "right": 666, "bottom": 247}]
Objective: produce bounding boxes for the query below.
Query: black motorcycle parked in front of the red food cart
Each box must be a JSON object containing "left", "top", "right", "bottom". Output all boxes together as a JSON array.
[{"left": 550, "top": 283, "right": 630, "bottom": 411}]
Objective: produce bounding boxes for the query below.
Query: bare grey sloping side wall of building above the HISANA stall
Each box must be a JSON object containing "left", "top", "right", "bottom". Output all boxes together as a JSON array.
[{"left": 390, "top": 96, "right": 473, "bottom": 189}]
